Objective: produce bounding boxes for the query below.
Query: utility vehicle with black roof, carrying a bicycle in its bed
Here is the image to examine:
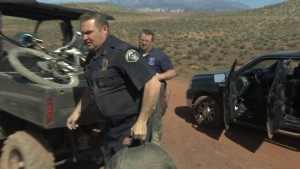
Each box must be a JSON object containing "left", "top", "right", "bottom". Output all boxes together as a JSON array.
[{"left": 0, "top": 0, "right": 113, "bottom": 169}]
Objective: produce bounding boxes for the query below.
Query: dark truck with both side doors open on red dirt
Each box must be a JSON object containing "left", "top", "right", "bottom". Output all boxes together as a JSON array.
[{"left": 186, "top": 51, "right": 300, "bottom": 138}]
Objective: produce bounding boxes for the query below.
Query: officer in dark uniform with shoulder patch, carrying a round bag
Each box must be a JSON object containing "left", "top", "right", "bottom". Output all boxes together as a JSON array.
[{"left": 67, "top": 12, "right": 160, "bottom": 164}]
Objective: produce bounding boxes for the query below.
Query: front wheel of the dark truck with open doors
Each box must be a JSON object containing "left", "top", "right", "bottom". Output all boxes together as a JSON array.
[{"left": 193, "top": 96, "right": 223, "bottom": 128}]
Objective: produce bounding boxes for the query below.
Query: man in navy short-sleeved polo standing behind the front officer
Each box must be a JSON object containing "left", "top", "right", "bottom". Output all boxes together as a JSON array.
[{"left": 139, "top": 29, "right": 176, "bottom": 145}]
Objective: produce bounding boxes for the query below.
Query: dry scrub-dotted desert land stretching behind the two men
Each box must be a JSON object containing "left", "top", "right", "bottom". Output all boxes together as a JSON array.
[{"left": 4, "top": 0, "right": 300, "bottom": 77}]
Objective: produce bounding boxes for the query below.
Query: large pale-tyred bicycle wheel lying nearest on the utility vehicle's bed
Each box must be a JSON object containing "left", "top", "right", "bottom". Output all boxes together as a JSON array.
[{"left": 8, "top": 47, "right": 79, "bottom": 87}]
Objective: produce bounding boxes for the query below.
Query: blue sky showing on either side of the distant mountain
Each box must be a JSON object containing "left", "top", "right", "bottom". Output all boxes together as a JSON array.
[{"left": 37, "top": 0, "right": 286, "bottom": 8}]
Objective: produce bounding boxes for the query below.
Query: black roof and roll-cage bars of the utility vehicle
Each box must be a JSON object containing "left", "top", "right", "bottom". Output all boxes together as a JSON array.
[{"left": 0, "top": 0, "right": 114, "bottom": 43}]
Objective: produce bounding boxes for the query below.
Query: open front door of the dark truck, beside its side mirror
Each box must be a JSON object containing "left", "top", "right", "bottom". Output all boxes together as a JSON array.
[{"left": 223, "top": 60, "right": 237, "bottom": 130}]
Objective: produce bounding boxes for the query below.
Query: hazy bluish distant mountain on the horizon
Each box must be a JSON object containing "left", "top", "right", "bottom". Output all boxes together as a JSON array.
[{"left": 107, "top": 0, "right": 250, "bottom": 11}]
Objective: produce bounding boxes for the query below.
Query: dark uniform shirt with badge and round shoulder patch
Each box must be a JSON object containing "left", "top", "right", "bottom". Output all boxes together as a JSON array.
[{"left": 85, "top": 35, "right": 155, "bottom": 121}]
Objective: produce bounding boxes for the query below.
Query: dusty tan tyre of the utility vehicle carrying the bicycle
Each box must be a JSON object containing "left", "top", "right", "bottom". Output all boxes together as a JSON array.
[{"left": 0, "top": 131, "right": 54, "bottom": 169}]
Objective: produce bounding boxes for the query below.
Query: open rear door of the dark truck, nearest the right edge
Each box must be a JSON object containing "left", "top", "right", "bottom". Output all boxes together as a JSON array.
[{"left": 266, "top": 59, "right": 291, "bottom": 139}]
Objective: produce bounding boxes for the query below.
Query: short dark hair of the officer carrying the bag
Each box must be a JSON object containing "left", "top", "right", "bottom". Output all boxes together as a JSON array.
[{"left": 79, "top": 11, "right": 109, "bottom": 28}]
